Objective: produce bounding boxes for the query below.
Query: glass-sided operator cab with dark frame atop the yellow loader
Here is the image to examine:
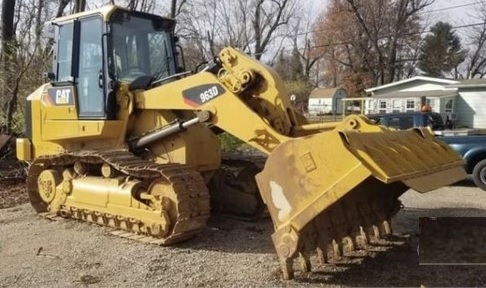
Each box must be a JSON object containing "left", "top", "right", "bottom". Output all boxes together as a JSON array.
[{"left": 49, "top": 6, "right": 177, "bottom": 120}]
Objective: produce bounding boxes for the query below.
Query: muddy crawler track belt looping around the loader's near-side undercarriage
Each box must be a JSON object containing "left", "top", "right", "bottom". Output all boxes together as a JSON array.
[{"left": 27, "top": 150, "right": 210, "bottom": 245}]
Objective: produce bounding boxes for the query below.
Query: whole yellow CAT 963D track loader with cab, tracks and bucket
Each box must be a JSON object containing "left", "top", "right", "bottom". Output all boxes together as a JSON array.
[{"left": 17, "top": 6, "right": 465, "bottom": 279}]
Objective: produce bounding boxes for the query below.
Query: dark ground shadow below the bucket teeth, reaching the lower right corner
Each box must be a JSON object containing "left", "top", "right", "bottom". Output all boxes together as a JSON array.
[{"left": 295, "top": 233, "right": 486, "bottom": 287}]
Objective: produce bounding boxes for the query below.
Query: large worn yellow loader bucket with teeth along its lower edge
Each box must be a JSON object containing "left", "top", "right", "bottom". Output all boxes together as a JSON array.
[{"left": 256, "top": 116, "right": 466, "bottom": 279}]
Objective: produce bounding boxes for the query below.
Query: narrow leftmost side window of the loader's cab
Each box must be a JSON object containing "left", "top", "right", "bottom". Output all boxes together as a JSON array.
[{"left": 56, "top": 23, "right": 74, "bottom": 81}]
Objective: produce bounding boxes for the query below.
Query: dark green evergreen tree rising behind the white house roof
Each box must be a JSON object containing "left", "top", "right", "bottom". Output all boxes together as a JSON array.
[{"left": 419, "top": 22, "right": 467, "bottom": 78}]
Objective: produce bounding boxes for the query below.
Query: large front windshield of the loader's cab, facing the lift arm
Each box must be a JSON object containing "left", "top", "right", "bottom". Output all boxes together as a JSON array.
[{"left": 112, "top": 13, "right": 175, "bottom": 81}]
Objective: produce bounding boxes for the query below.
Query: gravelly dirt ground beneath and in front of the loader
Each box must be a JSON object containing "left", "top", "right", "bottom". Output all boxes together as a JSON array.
[{"left": 0, "top": 181, "right": 486, "bottom": 287}]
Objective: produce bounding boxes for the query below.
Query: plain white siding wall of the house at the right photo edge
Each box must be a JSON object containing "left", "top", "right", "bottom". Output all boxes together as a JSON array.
[{"left": 456, "top": 90, "right": 486, "bottom": 128}]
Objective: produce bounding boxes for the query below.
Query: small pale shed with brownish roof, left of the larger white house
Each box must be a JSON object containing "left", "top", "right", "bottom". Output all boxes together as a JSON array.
[{"left": 307, "top": 87, "right": 347, "bottom": 115}]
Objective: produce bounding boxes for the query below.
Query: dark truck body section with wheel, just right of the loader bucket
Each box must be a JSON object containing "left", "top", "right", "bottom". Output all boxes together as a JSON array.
[{"left": 438, "top": 135, "right": 486, "bottom": 191}]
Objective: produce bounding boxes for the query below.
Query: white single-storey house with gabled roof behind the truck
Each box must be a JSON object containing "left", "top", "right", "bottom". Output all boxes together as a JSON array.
[{"left": 365, "top": 76, "right": 486, "bottom": 128}]
